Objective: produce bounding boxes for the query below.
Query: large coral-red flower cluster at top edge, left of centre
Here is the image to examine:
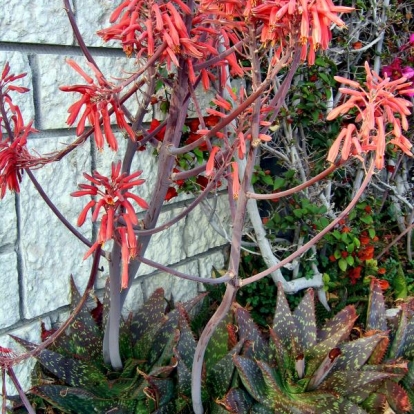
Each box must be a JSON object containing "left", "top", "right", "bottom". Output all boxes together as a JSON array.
[{"left": 98, "top": 0, "right": 243, "bottom": 89}]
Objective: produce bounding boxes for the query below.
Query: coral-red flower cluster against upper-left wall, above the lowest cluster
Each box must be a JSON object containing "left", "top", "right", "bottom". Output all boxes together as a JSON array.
[{"left": 59, "top": 59, "right": 135, "bottom": 151}]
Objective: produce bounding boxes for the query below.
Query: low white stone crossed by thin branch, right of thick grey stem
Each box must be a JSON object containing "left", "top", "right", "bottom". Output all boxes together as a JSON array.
[{"left": 142, "top": 260, "right": 199, "bottom": 303}]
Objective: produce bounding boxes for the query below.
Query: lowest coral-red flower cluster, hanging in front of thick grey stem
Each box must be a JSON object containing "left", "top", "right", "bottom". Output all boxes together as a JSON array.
[{"left": 71, "top": 162, "right": 148, "bottom": 288}]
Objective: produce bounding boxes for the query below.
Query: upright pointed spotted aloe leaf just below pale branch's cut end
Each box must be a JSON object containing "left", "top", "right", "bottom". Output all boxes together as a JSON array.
[{"left": 293, "top": 289, "right": 316, "bottom": 352}]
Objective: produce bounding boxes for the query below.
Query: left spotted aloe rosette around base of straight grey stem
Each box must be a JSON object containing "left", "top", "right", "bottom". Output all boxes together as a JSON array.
[{"left": 10, "top": 285, "right": 205, "bottom": 414}]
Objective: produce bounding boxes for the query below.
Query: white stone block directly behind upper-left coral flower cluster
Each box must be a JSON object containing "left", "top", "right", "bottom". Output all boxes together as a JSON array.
[{"left": 36, "top": 54, "right": 135, "bottom": 129}]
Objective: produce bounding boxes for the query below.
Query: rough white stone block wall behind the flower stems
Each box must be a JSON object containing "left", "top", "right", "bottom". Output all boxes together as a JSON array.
[{"left": 0, "top": 0, "right": 227, "bottom": 393}]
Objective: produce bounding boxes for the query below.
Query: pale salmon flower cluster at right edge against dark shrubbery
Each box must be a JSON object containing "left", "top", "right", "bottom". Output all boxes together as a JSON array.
[{"left": 327, "top": 62, "right": 414, "bottom": 169}]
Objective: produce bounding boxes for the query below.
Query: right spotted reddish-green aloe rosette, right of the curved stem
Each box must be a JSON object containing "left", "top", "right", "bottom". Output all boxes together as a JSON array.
[{"left": 206, "top": 283, "right": 414, "bottom": 414}]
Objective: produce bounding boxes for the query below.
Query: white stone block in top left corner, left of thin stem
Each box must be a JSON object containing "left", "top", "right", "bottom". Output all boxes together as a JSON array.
[{"left": 0, "top": 0, "right": 73, "bottom": 45}]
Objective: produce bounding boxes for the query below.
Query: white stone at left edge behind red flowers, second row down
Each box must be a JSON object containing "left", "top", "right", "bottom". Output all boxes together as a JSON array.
[{"left": 0, "top": 52, "right": 35, "bottom": 129}]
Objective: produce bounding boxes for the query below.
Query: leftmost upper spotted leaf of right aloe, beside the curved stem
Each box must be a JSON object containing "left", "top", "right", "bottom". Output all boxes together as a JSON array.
[{"left": 236, "top": 307, "right": 269, "bottom": 361}]
